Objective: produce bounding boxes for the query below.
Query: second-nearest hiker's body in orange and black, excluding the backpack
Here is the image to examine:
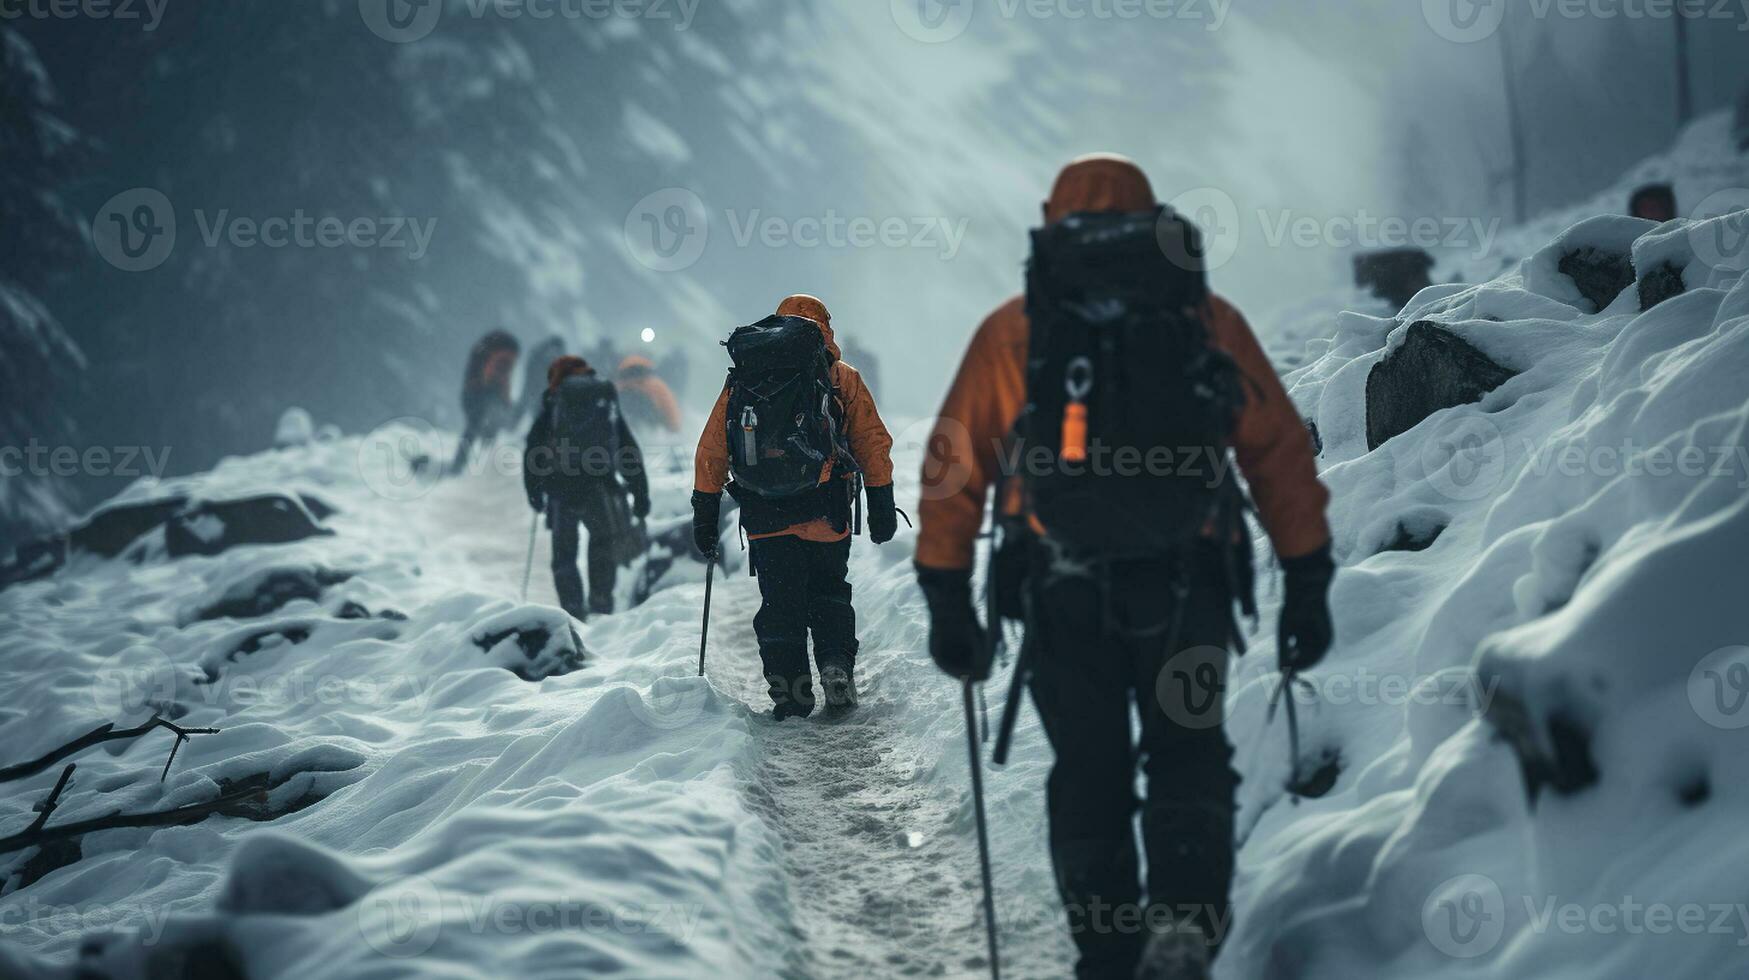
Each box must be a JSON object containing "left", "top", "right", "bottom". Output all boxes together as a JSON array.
[{"left": 693, "top": 296, "right": 899, "bottom": 719}]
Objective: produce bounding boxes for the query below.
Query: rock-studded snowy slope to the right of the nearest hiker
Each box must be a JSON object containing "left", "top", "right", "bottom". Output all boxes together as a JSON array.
[{"left": 1221, "top": 204, "right": 1749, "bottom": 978}]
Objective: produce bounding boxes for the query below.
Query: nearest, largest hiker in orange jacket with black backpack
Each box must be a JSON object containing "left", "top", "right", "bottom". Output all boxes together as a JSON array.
[{"left": 916, "top": 156, "right": 1334, "bottom": 978}]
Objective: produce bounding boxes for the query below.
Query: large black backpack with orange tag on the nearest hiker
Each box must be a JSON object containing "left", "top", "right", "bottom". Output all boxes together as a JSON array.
[{"left": 1016, "top": 208, "right": 1244, "bottom": 557}]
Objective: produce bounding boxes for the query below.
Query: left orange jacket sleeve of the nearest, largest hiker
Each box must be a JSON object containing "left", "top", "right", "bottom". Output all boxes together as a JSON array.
[{"left": 916, "top": 298, "right": 1027, "bottom": 571}]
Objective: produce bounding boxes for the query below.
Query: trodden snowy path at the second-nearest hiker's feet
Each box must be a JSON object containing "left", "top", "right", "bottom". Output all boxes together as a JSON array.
[{"left": 710, "top": 567, "right": 988, "bottom": 978}]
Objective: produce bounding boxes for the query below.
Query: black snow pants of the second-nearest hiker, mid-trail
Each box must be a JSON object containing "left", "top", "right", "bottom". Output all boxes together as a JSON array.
[{"left": 750, "top": 536, "right": 857, "bottom": 716}]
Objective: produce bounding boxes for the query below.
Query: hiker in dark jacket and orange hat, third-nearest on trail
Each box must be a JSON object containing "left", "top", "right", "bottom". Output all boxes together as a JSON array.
[{"left": 523, "top": 357, "right": 651, "bottom": 620}]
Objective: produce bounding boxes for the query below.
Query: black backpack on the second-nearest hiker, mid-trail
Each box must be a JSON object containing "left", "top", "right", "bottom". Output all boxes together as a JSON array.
[{"left": 724, "top": 317, "right": 854, "bottom": 504}]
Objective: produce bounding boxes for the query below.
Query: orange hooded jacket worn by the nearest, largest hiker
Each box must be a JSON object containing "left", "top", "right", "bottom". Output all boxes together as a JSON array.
[{"left": 916, "top": 154, "right": 1329, "bottom": 571}]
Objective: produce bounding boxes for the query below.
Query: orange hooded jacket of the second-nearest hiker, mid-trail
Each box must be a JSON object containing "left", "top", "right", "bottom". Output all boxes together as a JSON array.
[{"left": 693, "top": 296, "right": 892, "bottom": 543}]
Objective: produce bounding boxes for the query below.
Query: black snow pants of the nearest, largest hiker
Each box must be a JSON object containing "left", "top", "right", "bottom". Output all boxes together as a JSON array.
[{"left": 1027, "top": 544, "right": 1238, "bottom": 978}]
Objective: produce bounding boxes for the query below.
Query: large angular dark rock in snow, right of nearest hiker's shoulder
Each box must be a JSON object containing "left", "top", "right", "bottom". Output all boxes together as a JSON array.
[{"left": 1366, "top": 320, "right": 1515, "bottom": 450}]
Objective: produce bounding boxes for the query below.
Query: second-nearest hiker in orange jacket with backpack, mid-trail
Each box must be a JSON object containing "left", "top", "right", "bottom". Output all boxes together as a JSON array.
[{"left": 693, "top": 296, "right": 899, "bottom": 721}]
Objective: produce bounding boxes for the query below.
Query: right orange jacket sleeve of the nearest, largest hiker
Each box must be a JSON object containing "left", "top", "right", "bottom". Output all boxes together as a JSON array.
[{"left": 1210, "top": 296, "right": 1329, "bottom": 558}]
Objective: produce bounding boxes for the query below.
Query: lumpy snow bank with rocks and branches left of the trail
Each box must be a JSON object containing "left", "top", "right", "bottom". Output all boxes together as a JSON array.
[{"left": 0, "top": 431, "right": 789, "bottom": 978}]
